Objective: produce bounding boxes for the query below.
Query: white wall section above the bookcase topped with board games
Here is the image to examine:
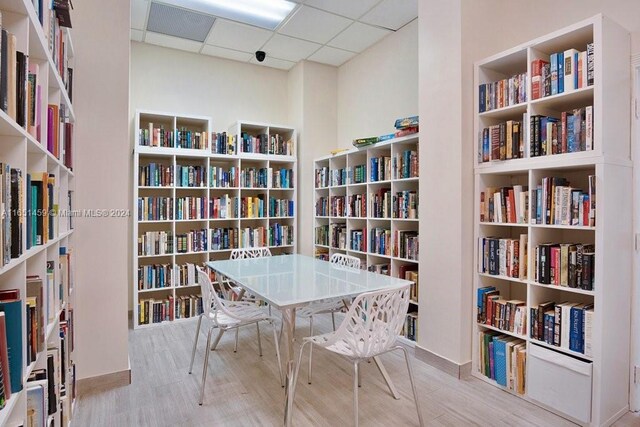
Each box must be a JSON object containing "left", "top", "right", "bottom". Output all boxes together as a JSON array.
[{"left": 331, "top": 19, "right": 418, "bottom": 148}]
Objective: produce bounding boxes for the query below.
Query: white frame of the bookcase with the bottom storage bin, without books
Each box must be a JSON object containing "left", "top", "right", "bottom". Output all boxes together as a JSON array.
[{"left": 472, "top": 15, "right": 632, "bottom": 426}]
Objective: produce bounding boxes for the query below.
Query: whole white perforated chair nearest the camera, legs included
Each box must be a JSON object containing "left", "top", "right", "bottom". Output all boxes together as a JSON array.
[{"left": 293, "top": 285, "right": 423, "bottom": 426}]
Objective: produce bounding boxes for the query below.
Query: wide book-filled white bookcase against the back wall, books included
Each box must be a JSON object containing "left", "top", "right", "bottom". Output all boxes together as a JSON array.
[{"left": 132, "top": 110, "right": 297, "bottom": 328}]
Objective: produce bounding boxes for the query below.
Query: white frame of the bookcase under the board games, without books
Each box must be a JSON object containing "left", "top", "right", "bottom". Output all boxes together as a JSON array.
[{"left": 313, "top": 134, "right": 419, "bottom": 345}]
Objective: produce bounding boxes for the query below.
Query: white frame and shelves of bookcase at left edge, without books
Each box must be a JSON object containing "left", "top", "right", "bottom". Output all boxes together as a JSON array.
[{"left": 0, "top": 0, "right": 75, "bottom": 427}]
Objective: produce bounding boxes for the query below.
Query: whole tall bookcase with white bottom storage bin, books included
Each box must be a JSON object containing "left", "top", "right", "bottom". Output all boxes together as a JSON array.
[{"left": 473, "top": 15, "right": 632, "bottom": 426}]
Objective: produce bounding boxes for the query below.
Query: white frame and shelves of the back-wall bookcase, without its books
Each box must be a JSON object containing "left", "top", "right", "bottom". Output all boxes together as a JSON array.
[{"left": 132, "top": 110, "right": 297, "bottom": 328}]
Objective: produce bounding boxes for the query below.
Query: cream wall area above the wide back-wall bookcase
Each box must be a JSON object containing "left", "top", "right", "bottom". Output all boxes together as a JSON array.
[{"left": 130, "top": 42, "right": 288, "bottom": 132}]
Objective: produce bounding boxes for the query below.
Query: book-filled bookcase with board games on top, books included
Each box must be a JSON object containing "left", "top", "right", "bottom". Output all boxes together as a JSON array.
[{"left": 313, "top": 134, "right": 419, "bottom": 345}]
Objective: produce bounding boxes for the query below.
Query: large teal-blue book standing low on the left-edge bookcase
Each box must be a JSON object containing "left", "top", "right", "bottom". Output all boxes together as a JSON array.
[{"left": 0, "top": 300, "right": 24, "bottom": 393}]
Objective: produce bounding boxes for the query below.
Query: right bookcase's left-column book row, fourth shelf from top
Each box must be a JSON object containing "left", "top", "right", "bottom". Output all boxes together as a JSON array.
[{"left": 478, "top": 234, "right": 528, "bottom": 280}]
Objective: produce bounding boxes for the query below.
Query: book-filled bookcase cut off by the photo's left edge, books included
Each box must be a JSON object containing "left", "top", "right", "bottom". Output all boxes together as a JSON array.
[{"left": 0, "top": 0, "right": 76, "bottom": 426}]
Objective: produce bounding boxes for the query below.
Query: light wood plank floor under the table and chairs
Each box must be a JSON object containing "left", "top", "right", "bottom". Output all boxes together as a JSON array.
[{"left": 72, "top": 316, "right": 640, "bottom": 427}]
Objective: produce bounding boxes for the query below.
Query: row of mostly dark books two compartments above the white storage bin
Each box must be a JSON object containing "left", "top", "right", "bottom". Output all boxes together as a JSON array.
[{"left": 534, "top": 243, "right": 595, "bottom": 291}]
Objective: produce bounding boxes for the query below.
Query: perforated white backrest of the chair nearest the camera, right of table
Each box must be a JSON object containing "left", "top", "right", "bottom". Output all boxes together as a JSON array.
[{"left": 334, "top": 285, "right": 410, "bottom": 358}]
